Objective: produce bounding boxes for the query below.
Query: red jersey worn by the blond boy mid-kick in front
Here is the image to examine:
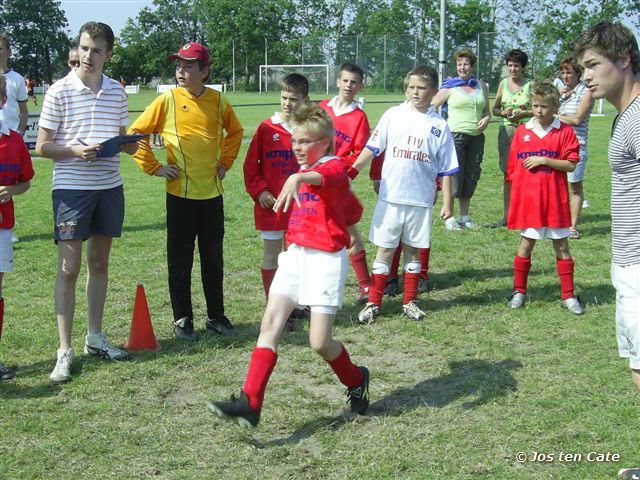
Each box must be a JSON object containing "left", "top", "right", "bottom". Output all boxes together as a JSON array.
[{"left": 286, "top": 156, "right": 349, "bottom": 252}]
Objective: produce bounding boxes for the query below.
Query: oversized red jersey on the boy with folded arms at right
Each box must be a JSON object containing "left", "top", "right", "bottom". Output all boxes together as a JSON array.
[{"left": 507, "top": 118, "right": 580, "bottom": 229}]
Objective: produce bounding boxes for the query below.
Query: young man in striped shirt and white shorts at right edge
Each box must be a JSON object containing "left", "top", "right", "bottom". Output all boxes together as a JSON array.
[{"left": 575, "top": 22, "right": 640, "bottom": 390}]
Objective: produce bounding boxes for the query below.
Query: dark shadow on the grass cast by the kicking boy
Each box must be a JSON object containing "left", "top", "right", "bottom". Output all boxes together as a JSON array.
[{"left": 250, "top": 359, "right": 522, "bottom": 448}]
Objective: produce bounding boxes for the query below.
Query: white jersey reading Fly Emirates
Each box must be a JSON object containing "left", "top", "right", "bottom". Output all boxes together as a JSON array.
[{"left": 367, "top": 102, "right": 458, "bottom": 207}]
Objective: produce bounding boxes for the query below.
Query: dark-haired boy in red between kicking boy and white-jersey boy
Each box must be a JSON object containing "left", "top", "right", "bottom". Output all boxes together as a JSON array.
[{"left": 319, "top": 63, "right": 371, "bottom": 303}]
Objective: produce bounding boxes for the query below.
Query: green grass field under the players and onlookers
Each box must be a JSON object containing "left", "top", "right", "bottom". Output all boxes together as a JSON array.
[{"left": 0, "top": 94, "right": 640, "bottom": 480}]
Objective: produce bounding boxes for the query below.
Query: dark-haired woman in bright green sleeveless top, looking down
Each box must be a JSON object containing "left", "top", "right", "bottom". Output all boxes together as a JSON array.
[{"left": 492, "top": 48, "right": 533, "bottom": 227}]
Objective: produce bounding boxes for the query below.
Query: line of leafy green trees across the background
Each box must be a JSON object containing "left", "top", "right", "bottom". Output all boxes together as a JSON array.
[{"left": 0, "top": 0, "right": 640, "bottom": 90}]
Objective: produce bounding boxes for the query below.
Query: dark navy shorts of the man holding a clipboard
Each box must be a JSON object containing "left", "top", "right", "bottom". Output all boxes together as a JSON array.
[{"left": 51, "top": 185, "right": 124, "bottom": 242}]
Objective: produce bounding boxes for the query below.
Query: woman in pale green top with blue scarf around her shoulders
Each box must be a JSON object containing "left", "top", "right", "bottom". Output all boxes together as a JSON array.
[{"left": 433, "top": 49, "right": 491, "bottom": 230}]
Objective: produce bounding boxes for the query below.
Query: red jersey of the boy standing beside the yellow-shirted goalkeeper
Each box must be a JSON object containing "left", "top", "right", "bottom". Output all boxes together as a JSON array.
[{"left": 243, "top": 113, "right": 300, "bottom": 231}]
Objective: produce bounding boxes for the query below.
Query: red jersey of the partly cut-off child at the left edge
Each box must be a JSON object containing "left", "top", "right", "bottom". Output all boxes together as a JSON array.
[{"left": 0, "top": 129, "right": 35, "bottom": 229}]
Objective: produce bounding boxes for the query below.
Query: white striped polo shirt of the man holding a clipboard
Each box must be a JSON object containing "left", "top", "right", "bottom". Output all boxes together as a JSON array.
[{"left": 39, "top": 70, "right": 128, "bottom": 190}]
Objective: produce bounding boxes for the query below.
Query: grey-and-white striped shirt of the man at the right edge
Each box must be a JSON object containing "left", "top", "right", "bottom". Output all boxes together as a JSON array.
[{"left": 609, "top": 95, "right": 640, "bottom": 266}]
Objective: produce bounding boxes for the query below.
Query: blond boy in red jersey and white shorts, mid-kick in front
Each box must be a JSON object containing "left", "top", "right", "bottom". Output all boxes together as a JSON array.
[{"left": 207, "top": 105, "right": 369, "bottom": 427}]
